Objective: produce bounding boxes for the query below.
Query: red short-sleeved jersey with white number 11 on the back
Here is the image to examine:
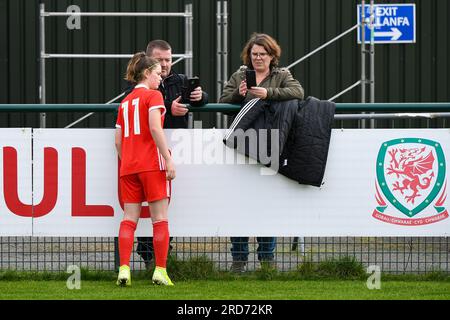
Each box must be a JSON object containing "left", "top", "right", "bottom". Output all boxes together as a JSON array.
[{"left": 116, "top": 84, "right": 166, "bottom": 177}]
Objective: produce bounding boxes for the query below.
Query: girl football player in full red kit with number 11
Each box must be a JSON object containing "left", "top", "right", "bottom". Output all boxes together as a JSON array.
[{"left": 115, "top": 52, "right": 175, "bottom": 286}]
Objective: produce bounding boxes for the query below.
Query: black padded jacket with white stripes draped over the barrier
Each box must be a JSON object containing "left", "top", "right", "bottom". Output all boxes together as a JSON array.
[{"left": 224, "top": 97, "right": 336, "bottom": 187}]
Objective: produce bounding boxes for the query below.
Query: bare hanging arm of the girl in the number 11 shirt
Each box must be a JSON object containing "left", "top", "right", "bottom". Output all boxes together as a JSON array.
[{"left": 148, "top": 108, "right": 175, "bottom": 180}]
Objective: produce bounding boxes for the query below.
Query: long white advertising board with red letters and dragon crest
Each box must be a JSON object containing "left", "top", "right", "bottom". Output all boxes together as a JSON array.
[{"left": 0, "top": 129, "right": 450, "bottom": 236}]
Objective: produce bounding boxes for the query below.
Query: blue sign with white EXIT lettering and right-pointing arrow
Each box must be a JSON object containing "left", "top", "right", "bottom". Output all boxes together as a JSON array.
[{"left": 357, "top": 3, "right": 416, "bottom": 43}]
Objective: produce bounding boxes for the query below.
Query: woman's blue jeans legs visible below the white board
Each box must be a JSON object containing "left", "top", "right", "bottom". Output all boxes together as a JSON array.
[{"left": 230, "top": 237, "right": 277, "bottom": 261}]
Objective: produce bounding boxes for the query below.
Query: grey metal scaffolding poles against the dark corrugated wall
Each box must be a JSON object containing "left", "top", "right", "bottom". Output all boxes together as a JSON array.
[{"left": 39, "top": 0, "right": 375, "bottom": 128}]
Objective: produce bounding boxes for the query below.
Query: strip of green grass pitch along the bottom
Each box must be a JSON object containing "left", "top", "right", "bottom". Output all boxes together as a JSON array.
[{"left": 0, "top": 278, "right": 450, "bottom": 300}]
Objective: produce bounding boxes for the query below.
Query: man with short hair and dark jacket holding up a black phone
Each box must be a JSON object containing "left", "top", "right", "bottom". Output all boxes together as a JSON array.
[{"left": 136, "top": 40, "right": 208, "bottom": 270}]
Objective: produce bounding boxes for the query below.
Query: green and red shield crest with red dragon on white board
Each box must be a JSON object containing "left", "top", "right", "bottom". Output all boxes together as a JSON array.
[{"left": 373, "top": 138, "right": 448, "bottom": 226}]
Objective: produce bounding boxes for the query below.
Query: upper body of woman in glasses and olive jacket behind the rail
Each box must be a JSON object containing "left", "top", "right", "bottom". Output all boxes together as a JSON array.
[{"left": 219, "top": 33, "right": 304, "bottom": 104}]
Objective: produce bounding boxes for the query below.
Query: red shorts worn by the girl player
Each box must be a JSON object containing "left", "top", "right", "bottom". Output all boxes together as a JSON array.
[{"left": 120, "top": 171, "right": 172, "bottom": 203}]
